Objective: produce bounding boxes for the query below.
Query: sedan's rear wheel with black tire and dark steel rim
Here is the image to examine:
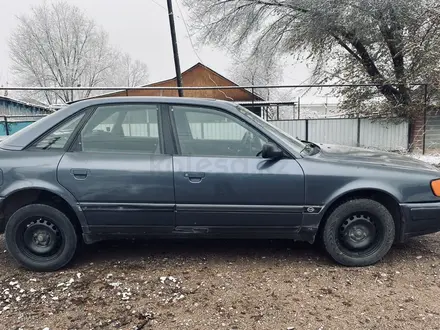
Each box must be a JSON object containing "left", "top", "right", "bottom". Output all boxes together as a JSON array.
[{"left": 5, "top": 204, "right": 77, "bottom": 272}]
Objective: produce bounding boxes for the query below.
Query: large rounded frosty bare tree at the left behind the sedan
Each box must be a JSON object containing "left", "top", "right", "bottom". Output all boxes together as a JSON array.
[{"left": 9, "top": 1, "right": 115, "bottom": 104}]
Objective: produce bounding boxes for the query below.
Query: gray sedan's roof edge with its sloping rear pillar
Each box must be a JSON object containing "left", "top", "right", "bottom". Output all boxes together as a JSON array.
[{"left": 0, "top": 96, "right": 238, "bottom": 150}]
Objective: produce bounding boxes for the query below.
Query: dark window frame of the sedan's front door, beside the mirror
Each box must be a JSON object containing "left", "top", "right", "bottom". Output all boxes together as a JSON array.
[{"left": 164, "top": 103, "right": 294, "bottom": 160}]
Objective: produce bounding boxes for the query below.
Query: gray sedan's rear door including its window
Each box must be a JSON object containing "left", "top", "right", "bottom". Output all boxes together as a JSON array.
[{"left": 58, "top": 103, "right": 175, "bottom": 234}]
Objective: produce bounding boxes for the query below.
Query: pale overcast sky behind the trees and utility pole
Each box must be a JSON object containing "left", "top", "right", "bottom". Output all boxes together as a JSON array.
[{"left": 0, "top": 0, "right": 309, "bottom": 90}]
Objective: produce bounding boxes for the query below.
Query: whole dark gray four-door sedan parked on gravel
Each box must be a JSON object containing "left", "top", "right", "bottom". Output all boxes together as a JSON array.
[{"left": 0, "top": 97, "right": 440, "bottom": 271}]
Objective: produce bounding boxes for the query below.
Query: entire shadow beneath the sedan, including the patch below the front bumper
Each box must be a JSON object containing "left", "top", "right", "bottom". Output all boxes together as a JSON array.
[{"left": 68, "top": 236, "right": 440, "bottom": 267}]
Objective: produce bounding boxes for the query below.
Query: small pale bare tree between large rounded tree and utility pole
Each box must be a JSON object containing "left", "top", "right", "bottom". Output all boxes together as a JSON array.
[{"left": 105, "top": 53, "right": 148, "bottom": 87}]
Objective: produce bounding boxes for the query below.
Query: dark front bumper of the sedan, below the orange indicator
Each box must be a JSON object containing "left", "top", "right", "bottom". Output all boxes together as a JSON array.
[{"left": 400, "top": 202, "right": 440, "bottom": 240}]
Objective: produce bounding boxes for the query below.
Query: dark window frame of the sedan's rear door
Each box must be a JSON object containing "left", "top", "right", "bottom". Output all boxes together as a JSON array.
[{"left": 66, "top": 102, "right": 169, "bottom": 156}]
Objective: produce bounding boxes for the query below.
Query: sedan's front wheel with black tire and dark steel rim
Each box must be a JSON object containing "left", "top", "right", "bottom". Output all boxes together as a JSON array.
[{"left": 322, "top": 199, "right": 395, "bottom": 267}]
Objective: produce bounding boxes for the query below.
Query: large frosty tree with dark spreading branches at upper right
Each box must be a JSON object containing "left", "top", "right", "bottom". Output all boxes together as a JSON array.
[{"left": 186, "top": 0, "right": 440, "bottom": 116}]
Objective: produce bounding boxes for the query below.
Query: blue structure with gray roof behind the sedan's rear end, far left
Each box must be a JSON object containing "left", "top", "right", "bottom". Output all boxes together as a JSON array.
[{"left": 0, "top": 96, "right": 53, "bottom": 136}]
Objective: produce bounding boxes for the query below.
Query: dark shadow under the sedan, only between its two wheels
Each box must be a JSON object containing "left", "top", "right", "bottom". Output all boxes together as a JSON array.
[{"left": 74, "top": 239, "right": 331, "bottom": 266}]
